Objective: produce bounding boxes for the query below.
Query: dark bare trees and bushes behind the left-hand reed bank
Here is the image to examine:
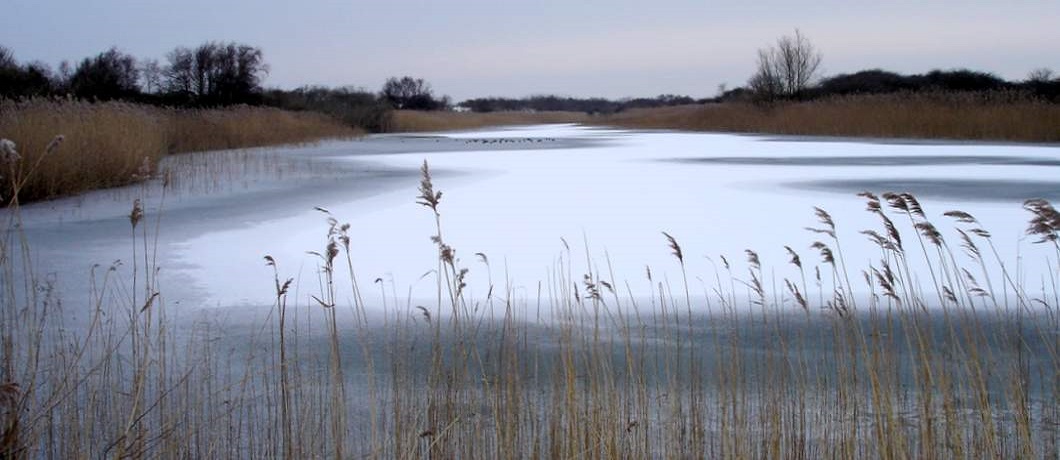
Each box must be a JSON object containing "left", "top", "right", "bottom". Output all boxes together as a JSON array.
[{"left": 0, "top": 41, "right": 452, "bottom": 131}]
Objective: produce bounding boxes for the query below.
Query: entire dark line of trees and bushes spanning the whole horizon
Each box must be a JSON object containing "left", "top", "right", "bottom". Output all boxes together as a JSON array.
[{"left": 6, "top": 36, "right": 1060, "bottom": 125}]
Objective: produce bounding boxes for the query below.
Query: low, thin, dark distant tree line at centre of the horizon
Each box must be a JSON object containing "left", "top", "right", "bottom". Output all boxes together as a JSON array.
[{"left": 459, "top": 94, "right": 703, "bottom": 113}]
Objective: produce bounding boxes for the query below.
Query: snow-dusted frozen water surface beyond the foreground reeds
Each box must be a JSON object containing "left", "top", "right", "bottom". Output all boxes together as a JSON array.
[{"left": 8, "top": 125, "right": 1060, "bottom": 317}]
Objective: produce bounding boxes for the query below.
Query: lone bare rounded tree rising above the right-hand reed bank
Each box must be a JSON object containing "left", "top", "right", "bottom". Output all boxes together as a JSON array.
[{"left": 747, "top": 29, "right": 822, "bottom": 101}]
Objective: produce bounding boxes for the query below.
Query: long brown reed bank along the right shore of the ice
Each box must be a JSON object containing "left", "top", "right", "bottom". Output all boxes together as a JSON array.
[{"left": 591, "top": 94, "right": 1060, "bottom": 142}]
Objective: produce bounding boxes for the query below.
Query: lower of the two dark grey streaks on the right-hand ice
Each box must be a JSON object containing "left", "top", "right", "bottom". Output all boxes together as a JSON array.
[{"left": 784, "top": 179, "right": 1060, "bottom": 202}]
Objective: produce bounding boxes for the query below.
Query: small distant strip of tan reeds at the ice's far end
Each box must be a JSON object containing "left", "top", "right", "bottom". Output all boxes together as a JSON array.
[{"left": 387, "top": 110, "right": 589, "bottom": 132}]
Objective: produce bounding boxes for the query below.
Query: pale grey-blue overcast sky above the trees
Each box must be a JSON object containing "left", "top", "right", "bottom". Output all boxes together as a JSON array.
[{"left": 0, "top": 0, "right": 1060, "bottom": 101}]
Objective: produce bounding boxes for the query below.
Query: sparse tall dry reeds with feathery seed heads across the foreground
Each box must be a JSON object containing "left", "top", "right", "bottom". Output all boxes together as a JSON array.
[{"left": 0, "top": 152, "right": 1060, "bottom": 459}]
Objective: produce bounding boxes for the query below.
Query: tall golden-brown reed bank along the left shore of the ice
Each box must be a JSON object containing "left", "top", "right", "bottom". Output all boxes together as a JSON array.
[{"left": 0, "top": 100, "right": 356, "bottom": 201}]
